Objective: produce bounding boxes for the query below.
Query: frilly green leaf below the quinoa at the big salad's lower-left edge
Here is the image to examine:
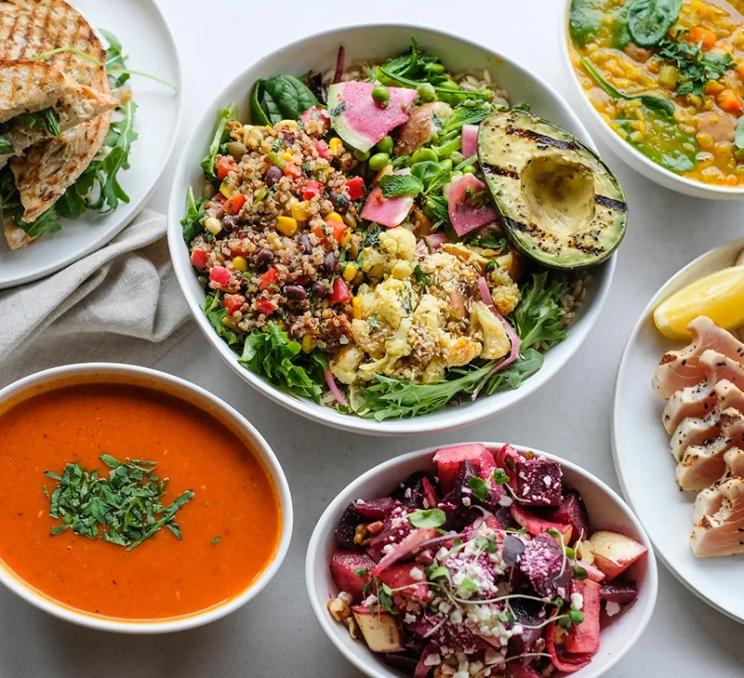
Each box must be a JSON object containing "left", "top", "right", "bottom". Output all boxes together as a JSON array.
[{"left": 238, "top": 321, "right": 323, "bottom": 401}]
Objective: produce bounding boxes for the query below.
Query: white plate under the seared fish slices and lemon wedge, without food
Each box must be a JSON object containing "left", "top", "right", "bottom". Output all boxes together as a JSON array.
[{"left": 612, "top": 238, "right": 744, "bottom": 622}]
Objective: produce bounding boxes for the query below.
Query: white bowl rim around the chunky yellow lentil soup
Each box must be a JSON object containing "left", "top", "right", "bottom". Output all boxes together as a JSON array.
[{"left": 560, "top": 0, "right": 744, "bottom": 200}]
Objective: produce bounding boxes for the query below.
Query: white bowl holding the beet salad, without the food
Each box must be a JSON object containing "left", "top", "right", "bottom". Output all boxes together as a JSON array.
[{"left": 305, "top": 443, "right": 658, "bottom": 678}]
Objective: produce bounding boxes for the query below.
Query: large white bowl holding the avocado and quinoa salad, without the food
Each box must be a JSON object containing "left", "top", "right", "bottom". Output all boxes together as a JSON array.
[{"left": 168, "top": 25, "right": 615, "bottom": 435}]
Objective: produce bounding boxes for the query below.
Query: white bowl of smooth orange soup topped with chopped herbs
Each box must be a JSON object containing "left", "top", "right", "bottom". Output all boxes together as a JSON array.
[{"left": 0, "top": 363, "right": 292, "bottom": 633}]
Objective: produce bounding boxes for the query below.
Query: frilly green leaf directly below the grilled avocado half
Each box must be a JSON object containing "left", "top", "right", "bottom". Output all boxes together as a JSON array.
[{"left": 513, "top": 271, "right": 568, "bottom": 351}]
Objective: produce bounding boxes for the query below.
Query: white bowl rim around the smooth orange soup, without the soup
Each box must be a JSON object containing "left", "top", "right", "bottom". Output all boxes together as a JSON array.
[{"left": 0, "top": 363, "right": 292, "bottom": 633}]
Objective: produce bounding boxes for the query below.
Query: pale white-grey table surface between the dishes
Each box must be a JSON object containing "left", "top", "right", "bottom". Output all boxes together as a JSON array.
[{"left": 0, "top": 0, "right": 744, "bottom": 678}]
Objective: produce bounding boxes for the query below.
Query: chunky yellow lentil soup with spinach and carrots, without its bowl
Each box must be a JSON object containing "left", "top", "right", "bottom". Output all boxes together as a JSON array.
[{"left": 569, "top": 0, "right": 744, "bottom": 187}]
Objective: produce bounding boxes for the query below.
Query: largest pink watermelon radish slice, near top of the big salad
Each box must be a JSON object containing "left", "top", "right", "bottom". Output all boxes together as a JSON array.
[{"left": 328, "top": 80, "right": 418, "bottom": 152}]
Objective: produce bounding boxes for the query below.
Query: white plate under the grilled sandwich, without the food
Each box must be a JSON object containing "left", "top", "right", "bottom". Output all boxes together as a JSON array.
[{"left": 0, "top": 0, "right": 182, "bottom": 289}]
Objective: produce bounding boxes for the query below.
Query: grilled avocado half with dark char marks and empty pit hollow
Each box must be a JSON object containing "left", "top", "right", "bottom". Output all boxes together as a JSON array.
[{"left": 478, "top": 110, "right": 628, "bottom": 269}]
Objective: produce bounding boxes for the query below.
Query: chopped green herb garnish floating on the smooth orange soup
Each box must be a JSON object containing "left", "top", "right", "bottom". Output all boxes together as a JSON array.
[{"left": 44, "top": 454, "right": 195, "bottom": 551}]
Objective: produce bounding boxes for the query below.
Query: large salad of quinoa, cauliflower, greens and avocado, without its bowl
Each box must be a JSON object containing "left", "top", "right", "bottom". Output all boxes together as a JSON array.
[{"left": 182, "top": 40, "right": 627, "bottom": 420}]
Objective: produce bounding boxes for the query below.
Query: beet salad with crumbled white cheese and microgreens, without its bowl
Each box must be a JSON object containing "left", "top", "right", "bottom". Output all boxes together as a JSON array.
[{"left": 327, "top": 444, "right": 646, "bottom": 678}]
